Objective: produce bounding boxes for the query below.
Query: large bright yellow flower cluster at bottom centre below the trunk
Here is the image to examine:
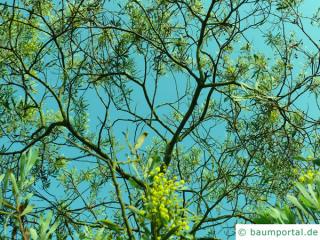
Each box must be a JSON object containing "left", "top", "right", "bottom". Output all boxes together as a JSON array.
[{"left": 142, "top": 167, "right": 189, "bottom": 235}]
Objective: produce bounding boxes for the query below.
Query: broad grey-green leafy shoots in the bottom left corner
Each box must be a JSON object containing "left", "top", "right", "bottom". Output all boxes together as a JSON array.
[{"left": 0, "top": 149, "right": 58, "bottom": 240}]
